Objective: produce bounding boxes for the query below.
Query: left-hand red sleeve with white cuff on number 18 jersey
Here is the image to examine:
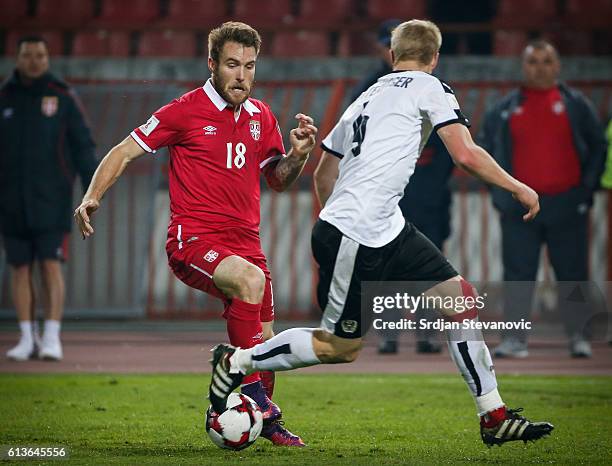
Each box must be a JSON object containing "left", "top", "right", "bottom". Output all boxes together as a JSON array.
[{"left": 130, "top": 100, "right": 184, "bottom": 153}]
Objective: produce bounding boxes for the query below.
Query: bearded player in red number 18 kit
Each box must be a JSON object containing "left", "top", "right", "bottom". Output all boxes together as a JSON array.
[{"left": 75, "top": 22, "right": 317, "bottom": 446}]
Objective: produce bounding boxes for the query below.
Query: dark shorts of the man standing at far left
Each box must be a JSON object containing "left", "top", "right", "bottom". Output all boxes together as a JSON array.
[{"left": 3, "top": 231, "right": 68, "bottom": 267}]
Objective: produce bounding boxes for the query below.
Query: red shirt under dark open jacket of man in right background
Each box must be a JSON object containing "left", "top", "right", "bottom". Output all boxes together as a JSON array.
[{"left": 510, "top": 87, "right": 580, "bottom": 195}]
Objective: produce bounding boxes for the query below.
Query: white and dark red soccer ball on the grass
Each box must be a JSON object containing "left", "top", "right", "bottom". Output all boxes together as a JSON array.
[{"left": 206, "top": 393, "right": 263, "bottom": 450}]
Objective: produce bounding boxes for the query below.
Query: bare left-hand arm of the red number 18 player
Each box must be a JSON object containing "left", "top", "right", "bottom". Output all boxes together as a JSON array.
[{"left": 74, "top": 136, "right": 146, "bottom": 238}]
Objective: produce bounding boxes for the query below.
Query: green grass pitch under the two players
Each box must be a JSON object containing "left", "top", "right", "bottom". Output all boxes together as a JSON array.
[{"left": 0, "top": 374, "right": 612, "bottom": 465}]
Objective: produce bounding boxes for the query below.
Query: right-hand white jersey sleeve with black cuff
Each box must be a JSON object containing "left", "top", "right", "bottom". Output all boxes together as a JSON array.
[{"left": 420, "top": 79, "right": 470, "bottom": 131}]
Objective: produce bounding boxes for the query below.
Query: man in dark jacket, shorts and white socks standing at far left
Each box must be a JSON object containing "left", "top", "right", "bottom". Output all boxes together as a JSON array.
[{"left": 0, "top": 36, "right": 96, "bottom": 361}]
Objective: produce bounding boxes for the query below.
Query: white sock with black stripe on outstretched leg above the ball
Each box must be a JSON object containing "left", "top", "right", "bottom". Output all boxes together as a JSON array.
[{"left": 232, "top": 328, "right": 321, "bottom": 374}]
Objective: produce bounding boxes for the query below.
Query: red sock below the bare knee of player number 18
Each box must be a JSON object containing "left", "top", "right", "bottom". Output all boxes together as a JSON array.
[{"left": 223, "top": 299, "right": 263, "bottom": 385}]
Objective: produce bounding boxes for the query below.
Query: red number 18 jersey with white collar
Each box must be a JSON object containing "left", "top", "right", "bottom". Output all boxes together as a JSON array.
[{"left": 131, "top": 80, "right": 285, "bottom": 251}]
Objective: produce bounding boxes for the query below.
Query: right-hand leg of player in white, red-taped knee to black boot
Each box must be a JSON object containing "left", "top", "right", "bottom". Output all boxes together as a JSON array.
[{"left": 426, "top": 275, "right": 553, "bottom": 447}]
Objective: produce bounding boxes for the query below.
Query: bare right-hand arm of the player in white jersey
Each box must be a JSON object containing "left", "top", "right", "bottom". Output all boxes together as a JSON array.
[{"left": 437, "top": 123, "right": 540, "bottom": 221}]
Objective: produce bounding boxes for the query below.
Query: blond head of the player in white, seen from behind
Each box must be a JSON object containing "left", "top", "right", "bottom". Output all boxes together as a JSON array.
[{"left": 391, "top": 19, "right": 442, "bottom": 65}]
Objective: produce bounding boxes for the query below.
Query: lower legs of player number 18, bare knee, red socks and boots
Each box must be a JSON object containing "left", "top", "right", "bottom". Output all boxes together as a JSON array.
[{"left": 211, "top": 256, "right": 304, "bottom": 446}]
